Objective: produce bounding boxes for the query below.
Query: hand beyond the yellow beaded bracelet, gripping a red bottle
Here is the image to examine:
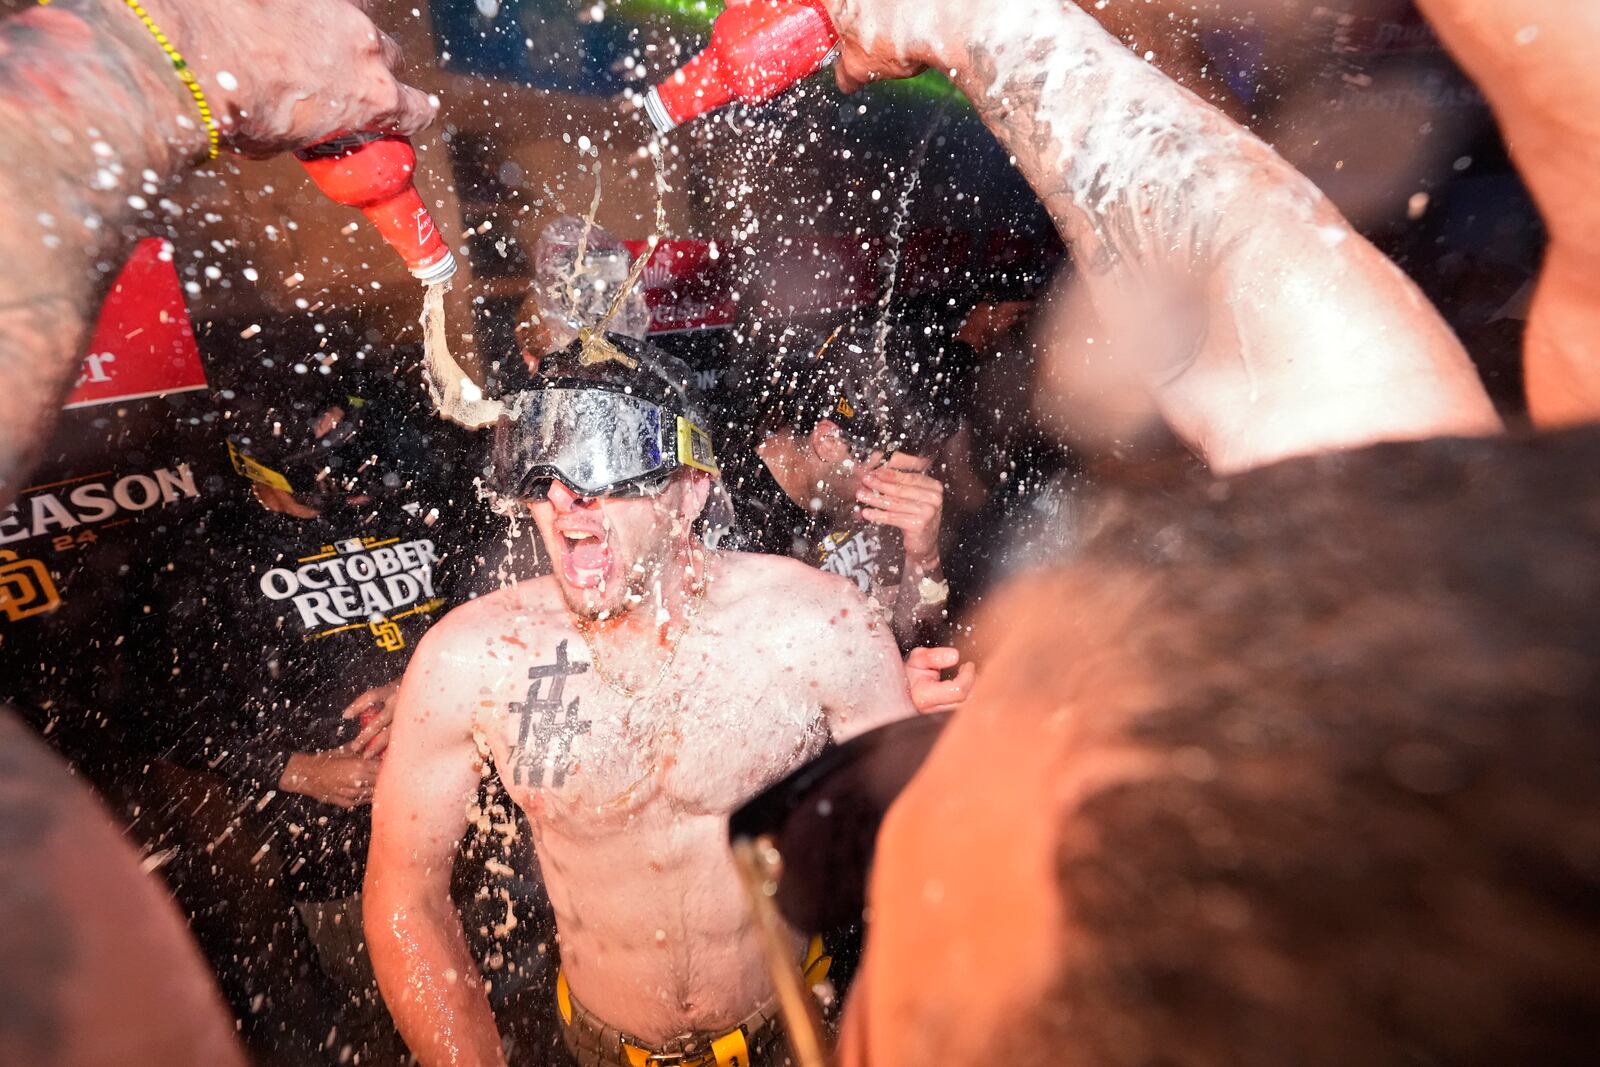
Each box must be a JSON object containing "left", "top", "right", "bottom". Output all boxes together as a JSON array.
[{"left": 146, "top": 0, "right": 435, "bottom": 157}]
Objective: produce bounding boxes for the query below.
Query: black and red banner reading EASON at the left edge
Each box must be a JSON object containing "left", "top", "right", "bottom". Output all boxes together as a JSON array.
[{"left": 0, "top": 233, "right": 214, "bottom": 713}]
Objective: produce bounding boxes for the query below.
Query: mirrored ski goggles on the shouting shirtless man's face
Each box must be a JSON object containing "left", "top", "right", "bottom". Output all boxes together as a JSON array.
[{"left": 491, "top": 379, "right": 722, "bottom": 501}]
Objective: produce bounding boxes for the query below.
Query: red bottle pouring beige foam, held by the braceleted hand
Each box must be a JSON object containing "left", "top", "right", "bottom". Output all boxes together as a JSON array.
[{"left": 294, "top": 133, "right": 456, "bottom": 285}]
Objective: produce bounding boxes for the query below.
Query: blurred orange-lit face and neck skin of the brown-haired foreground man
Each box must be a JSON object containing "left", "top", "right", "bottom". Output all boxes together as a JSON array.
[{"left": 838, "top": 573, "right": 1154, "bottom": 1067}]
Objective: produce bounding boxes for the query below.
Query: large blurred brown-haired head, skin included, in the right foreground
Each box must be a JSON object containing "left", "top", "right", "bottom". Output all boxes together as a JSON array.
[{"left": 842, "top": 430, "right": 1600, "bottom": 1067}]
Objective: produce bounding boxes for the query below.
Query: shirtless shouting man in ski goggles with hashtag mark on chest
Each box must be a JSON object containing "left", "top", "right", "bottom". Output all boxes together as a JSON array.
[{"left": 366, "top": 334, "right": 914, "bottom": 1067}]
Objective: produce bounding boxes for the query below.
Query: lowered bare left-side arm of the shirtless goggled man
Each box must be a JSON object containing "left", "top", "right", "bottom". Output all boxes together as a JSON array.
[{"left": 363, "top": 617, "right": 506, "bottom": 1067}]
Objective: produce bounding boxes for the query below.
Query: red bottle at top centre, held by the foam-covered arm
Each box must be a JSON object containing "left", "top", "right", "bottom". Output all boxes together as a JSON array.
[{"left": 645, "top": 0, "right": 838, "bottom": 133}]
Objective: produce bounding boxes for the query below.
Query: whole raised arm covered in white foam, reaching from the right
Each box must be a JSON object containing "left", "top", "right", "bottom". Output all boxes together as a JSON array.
[{"left": 832, "top": 0, "right": 1499, "bottom": 472}]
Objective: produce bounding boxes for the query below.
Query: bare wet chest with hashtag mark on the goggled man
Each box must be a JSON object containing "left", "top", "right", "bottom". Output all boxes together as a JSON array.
[{"left": 488, "top": 638, "right": 827, "bottom": 837}]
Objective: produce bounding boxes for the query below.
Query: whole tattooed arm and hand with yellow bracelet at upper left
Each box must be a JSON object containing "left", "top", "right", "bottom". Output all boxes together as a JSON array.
[{"left": 0, "top": 0, "right": 434, "bottom": 506}]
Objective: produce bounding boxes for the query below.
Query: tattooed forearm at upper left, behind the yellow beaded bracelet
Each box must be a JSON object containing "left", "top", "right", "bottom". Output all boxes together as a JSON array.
[{"left": 0, "top": 0, "right": 205, "bottom": 506}]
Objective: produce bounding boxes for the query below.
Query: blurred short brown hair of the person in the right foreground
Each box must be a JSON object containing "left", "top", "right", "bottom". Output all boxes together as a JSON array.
[{"left": 987, "top": 430, "right": 1600, "bottom": 1067}]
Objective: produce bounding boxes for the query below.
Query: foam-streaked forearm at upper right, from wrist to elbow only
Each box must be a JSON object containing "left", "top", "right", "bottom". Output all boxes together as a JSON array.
[{"left": 946, "top": 0, "right": 1323, "bottom": 319}]
